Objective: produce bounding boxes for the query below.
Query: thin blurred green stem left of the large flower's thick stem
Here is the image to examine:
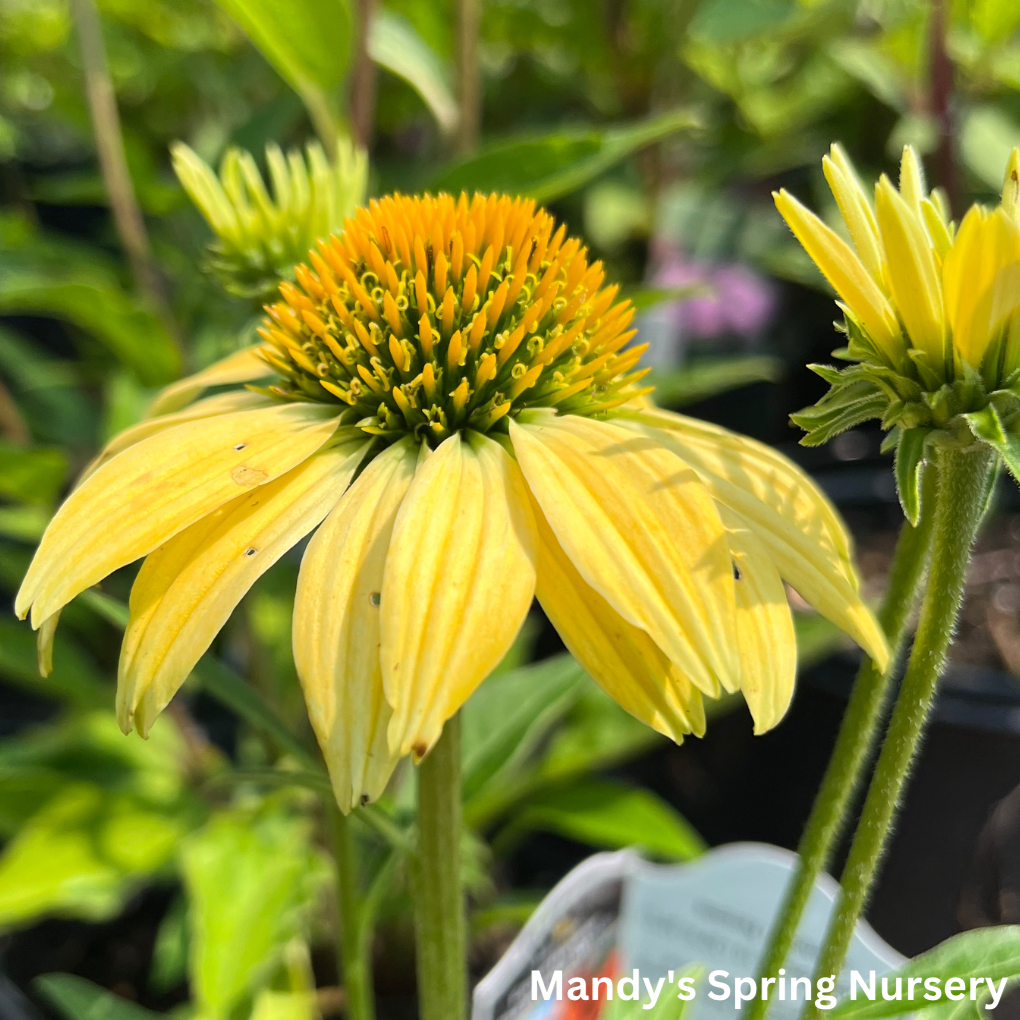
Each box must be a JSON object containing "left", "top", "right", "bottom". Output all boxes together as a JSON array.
[{"left": 329, "top": 800, "right": 375, "bottom": 1020}]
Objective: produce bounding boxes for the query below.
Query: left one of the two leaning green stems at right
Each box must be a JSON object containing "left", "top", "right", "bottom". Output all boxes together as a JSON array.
[{"left": 749, "top": 465, "right": 935, "bottom": 1020}]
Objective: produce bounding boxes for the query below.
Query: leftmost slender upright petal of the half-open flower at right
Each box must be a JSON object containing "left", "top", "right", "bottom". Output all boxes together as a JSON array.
[{"left": 772, "top": 190, "right": 903, "bottom": 356}]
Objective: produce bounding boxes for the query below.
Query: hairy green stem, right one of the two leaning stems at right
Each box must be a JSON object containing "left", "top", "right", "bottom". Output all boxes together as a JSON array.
[{"left": 803, "top": 447, "right": 995, "bottom": 1003}]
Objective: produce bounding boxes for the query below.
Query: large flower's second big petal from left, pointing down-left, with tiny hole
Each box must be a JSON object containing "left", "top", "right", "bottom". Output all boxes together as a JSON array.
[{"left": 117, "top": 439, "right": 371, "bottom": 736}]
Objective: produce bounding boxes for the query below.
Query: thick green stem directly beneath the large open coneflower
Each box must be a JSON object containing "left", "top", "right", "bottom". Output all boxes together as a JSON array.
[{"left": 415, "top": 716, "right": 467, "bottom": 1020}]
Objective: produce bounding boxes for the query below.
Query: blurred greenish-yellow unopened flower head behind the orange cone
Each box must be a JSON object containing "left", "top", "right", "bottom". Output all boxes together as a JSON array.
[{"left": 170, "top": 141, "right": 368, "bottom": 301}]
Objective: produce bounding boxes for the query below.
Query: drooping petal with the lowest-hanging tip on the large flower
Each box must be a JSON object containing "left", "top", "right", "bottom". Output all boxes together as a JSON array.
[{"left": 294, "top": 439, "right": 418, "bottom": 813}]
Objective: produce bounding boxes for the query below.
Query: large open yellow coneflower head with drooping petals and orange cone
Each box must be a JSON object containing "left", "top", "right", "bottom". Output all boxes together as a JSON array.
[{"left": 16, "top": 196, "right": 887, "bottom": 811}]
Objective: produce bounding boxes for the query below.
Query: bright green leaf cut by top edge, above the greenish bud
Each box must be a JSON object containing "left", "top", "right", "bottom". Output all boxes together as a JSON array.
[{"left": 210, "top": 0, "right": 353, "bottom": 141}]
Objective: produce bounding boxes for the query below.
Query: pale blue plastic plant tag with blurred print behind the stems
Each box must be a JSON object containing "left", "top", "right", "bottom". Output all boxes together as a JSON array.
[{"left": 472, "top": 844, "right": 906, "bottom": 1020}]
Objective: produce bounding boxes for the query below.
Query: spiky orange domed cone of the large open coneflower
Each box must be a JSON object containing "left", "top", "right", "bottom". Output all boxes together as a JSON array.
[{"left": 260, "top": 195, "right": 646, "bottom": 446}]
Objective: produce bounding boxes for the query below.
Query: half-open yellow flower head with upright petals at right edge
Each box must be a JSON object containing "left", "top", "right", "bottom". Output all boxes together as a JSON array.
[{"left": 774, "top": 145, "right": 1020, "bottom": 522}]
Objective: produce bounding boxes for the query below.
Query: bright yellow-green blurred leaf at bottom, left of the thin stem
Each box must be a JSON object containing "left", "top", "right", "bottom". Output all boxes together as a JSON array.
[{"left": 182, "top": 811, "right": 327, "bottom": 1020}]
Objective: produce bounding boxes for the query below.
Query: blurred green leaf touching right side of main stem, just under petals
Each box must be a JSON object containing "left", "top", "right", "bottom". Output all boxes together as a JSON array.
[{"left": 461, "top": 655, "right": 585, "bottom": 798}]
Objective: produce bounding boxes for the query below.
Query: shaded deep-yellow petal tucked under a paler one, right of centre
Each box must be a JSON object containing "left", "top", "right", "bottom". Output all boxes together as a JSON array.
[{"left": 533, "top": 495, "right": 705, "bottom": 744}]
